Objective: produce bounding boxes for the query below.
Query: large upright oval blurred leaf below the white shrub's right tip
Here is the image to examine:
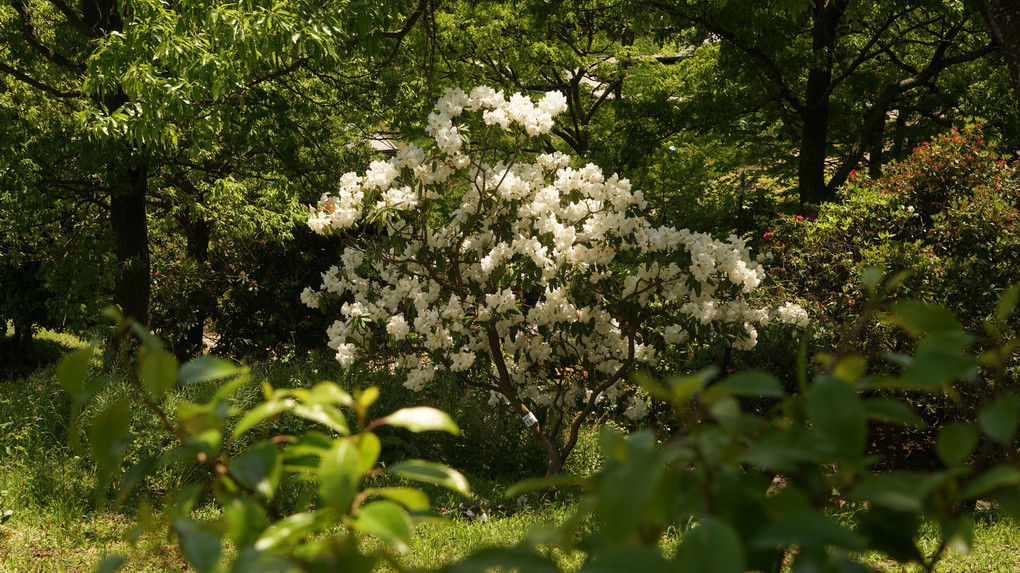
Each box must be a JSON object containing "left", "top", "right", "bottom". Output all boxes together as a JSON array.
[{"left": 808, "top": 376, "right": 867, "bottom": 459}]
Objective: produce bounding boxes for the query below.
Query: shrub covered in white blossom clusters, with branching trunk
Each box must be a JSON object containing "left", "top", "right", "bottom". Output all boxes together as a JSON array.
[{"left": 302, "top": 87, "right": 807, "bottom": 472}]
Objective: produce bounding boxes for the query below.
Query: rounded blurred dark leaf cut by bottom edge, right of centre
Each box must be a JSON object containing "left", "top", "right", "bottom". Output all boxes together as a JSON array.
[{"left": 673, "top": 517, "right": 745, "bottom": 573}]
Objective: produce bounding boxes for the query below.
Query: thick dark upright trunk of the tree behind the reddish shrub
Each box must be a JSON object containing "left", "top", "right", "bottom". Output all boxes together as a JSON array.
[{"left": 798, "top": 0, "right": 847, "bottom": 205}]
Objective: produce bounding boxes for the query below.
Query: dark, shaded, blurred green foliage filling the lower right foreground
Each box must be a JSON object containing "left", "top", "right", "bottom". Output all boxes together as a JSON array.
[{"left": 443, "top": 291, "right": 1020, "bottom": 573}]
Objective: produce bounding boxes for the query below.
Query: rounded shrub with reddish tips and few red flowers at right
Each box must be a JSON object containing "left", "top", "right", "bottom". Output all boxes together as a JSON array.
[{"left": 764, "top": 127, "right": 1020, "bottom": 374}]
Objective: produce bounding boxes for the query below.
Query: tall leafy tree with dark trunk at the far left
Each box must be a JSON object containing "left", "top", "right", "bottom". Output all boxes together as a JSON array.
[{"left": 0, "top": 0, "right": 430, "bottom": 330}]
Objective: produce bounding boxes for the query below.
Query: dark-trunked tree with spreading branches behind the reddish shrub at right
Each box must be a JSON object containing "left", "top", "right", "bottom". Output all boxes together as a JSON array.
[{"left": 656, "top": 0, "right": 995, "bottom": 203}]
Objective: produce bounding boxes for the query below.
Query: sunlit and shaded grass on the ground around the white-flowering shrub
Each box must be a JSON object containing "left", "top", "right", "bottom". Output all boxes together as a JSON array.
[{"left": 0, "top": 324, "right": 1020, "bottom": 573}]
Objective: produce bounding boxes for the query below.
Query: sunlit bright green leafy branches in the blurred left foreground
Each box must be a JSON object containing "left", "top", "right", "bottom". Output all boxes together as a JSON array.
[{"left": 57, "top": 311, "right": 470, "bottom": 571}]
